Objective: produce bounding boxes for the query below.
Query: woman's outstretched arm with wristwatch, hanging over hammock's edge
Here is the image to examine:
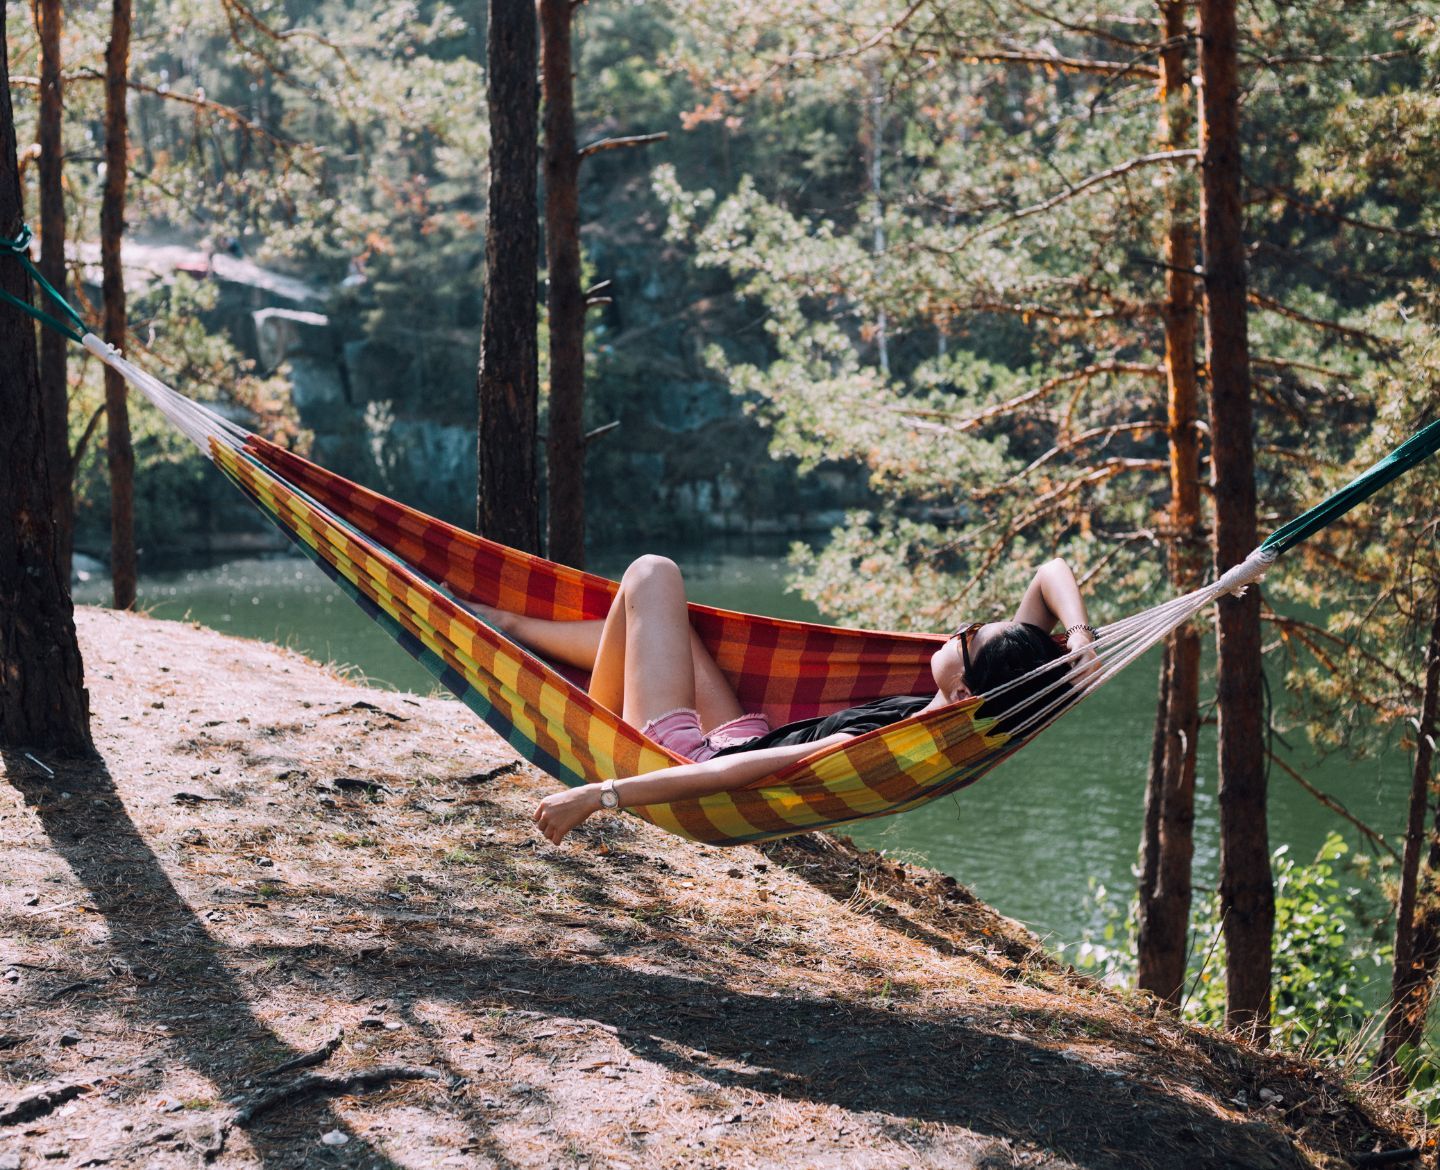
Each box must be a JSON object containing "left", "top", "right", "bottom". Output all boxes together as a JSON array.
[{"left": 534, "top": 732, "right": 852, "bottom": 844}]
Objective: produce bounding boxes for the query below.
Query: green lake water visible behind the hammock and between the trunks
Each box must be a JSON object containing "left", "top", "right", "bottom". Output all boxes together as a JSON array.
[{"left": 75, "top": 549, "right": 1410, "bottom": 950}]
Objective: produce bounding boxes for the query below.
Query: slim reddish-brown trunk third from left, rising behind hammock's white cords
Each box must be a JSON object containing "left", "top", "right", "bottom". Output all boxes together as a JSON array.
[{"left": 99, "top": 0, "right": 135, "bottom": 609}]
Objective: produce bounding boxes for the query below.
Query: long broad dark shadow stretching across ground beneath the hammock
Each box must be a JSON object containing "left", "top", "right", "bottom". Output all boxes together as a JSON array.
[{"left": 272, "top": 944, "right": 1347, "bottom": 1170}]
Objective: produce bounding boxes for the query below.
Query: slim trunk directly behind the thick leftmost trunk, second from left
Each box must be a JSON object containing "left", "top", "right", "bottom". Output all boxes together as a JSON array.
[{"left": 36, "top": 0, "right": 75, "bottom": 582}]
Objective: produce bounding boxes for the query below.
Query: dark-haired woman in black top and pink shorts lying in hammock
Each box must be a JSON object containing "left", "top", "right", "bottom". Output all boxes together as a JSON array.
[{"left": 475, "top": 556, "right": 1094, "bottom": 844}]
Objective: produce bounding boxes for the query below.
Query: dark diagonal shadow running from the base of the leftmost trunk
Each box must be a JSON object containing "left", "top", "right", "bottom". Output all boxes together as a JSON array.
[{"left": 0, "top": 751, "right": 507, "bottom": 1170}]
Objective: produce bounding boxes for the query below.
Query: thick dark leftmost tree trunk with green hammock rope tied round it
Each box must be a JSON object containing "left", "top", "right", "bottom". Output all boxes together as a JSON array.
[{"left": 0, "top": 6, "right": 91, "bottom": 754}]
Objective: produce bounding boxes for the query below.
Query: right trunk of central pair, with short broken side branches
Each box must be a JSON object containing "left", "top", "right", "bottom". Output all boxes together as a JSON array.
[{"left": 540, "top": 0, "right": 585, "bottom": 568}]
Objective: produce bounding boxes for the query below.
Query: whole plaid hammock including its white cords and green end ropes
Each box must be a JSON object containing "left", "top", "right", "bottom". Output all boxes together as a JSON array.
[{"left": 0, "top": 229, "right": 1440, "bottom": 844}]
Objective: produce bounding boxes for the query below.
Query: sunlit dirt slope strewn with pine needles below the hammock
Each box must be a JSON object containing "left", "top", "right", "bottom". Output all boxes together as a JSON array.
[{"left": 0, "top": 609, "right": 1428, "bottom": 1170}]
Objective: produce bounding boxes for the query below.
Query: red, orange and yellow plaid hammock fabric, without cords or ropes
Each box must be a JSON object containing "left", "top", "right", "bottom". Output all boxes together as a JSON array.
[{"left": 209, "top": 435, "right": 1018, "bottom": 844}]
